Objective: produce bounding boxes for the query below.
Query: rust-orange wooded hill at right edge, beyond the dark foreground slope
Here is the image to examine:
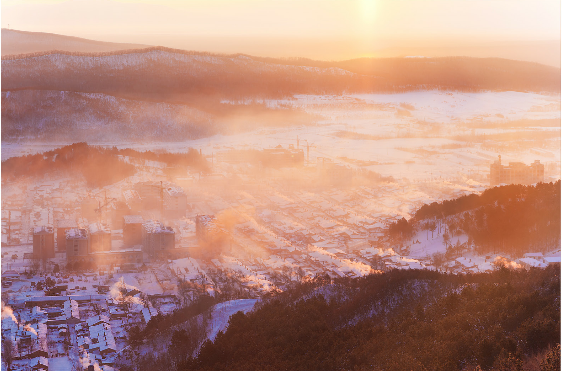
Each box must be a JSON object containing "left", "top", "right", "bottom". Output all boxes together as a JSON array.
[{"left": 388, "top": 180, "right": 561, "bottom": 256}]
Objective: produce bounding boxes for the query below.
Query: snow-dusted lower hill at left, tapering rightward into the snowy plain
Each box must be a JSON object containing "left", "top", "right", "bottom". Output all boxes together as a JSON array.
[{"left": 2, "top": 90, "right": 313, "bottom": 143}]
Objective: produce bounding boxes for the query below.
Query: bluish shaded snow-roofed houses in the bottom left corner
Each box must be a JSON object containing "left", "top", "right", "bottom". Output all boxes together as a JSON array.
[{"left": 2, "top": 282, "right": 163, "bottom": 371}]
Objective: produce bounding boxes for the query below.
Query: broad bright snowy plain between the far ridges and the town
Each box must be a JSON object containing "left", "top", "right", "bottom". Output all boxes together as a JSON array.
[{"left": 2, "top": 91, "right": 560, "bottom": 181}]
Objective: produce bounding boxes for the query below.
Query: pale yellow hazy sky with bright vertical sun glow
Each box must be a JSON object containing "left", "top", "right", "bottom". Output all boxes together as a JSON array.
[{"left": 1, "top": 0, "right": 560, "bottom": 59}]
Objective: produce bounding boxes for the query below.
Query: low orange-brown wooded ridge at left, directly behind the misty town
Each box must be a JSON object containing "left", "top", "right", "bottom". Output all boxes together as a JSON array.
[{"left": 2, "top": 143, "right": 208, "bottom": 187}]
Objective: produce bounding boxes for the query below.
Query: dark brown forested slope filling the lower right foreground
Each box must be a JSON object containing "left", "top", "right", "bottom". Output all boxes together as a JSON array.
[{"left": 177, "top": 265, "right": 560, "bottom": 370}]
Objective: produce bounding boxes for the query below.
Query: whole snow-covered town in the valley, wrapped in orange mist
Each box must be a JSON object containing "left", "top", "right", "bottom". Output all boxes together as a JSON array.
[{"left": 2, "top": 145, "right": 560, "bottom": 371}]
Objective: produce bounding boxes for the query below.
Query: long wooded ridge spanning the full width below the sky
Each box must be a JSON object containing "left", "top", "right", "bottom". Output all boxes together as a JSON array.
[{"left": 2, "top": 47, "right": 560, "bottom": 103}]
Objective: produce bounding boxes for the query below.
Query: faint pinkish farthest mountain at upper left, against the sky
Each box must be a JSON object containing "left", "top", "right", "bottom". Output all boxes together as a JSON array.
[{"left": 2, "top": 28, "right": 146, "bottom": 56}]
